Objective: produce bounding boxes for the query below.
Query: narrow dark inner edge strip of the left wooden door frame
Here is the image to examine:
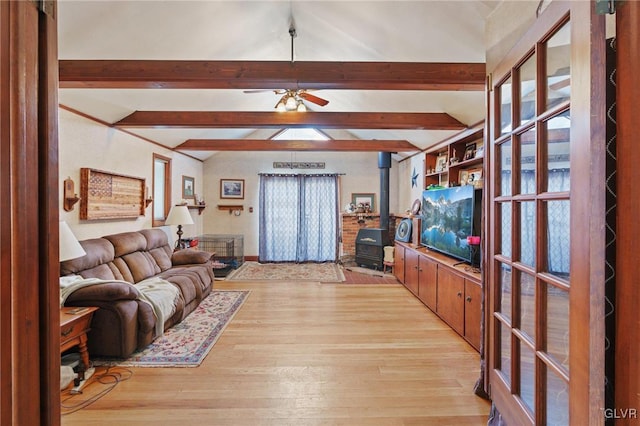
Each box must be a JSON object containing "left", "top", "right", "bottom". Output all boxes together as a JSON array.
[{"left": 37, "top": 2, "right": 61, "bottom": 425}]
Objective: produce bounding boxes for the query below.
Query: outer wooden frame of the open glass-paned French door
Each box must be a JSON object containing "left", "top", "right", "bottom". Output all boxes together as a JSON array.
[{"left": 485, "top": 0, "right": 606, "bottom": 425}]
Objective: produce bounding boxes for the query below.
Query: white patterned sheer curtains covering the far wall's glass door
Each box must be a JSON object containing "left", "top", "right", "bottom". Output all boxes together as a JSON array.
[{"left": 258, "top": 175, "right": 338, "bottom": 262}]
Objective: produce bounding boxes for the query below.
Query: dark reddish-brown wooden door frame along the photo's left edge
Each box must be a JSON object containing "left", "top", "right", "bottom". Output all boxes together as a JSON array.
[{"left": 0, "top": 1, "right": 60, "bottom": 426}]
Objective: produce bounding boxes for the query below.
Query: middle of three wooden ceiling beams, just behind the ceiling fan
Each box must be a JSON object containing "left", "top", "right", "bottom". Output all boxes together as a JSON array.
[{"left": 114, "top": 111, "right": 466, "bottom": 130}]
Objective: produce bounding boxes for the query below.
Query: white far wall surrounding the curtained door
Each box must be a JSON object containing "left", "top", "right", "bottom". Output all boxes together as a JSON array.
[{"left": 203, "top": 152, "right": 399, "bottom": 256}]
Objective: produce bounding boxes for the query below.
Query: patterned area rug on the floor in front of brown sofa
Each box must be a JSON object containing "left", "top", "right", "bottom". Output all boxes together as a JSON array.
[{"left": 93, "top": 290, "right": 249, "bottom": 367}]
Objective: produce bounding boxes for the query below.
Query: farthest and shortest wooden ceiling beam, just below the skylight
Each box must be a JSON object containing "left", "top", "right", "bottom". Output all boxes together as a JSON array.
[{"left": 175, "top": 139, "right": 420, "bottom": 152}]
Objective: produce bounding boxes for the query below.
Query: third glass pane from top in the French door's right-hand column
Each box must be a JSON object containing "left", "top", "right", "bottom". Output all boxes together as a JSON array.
[{"left": 545, "top": 200, "right": 571, "bottom": 281}]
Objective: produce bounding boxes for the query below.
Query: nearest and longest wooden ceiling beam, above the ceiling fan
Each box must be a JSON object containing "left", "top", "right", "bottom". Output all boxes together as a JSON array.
[{"left": 58, "top": 60, "right": 486, "bottom": 91}]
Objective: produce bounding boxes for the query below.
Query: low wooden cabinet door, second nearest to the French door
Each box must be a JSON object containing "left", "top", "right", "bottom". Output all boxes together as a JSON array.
[{"left": 436, "top": 267, "right": 464, "bottom": 336}]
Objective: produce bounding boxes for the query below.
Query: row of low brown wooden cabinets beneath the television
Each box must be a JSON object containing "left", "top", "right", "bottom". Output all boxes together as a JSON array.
[{"left": 393, "top": 241, "right": 482, "bottom": 350}]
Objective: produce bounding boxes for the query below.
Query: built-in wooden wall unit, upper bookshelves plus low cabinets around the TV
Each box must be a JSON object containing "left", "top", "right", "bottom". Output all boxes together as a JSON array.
[{"left": 393, "top": 123, "right": 484, "bottom": 351}]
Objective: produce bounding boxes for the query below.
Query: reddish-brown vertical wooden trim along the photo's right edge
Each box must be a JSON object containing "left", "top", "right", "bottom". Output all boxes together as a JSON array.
[{"left": 615, "top": 1, "right": 640, "bottom": 425}]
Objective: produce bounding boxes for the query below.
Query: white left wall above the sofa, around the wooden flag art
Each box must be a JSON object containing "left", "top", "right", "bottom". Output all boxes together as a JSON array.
[{"left": 59, "top": 109, "right": 204, "bottom": 240}]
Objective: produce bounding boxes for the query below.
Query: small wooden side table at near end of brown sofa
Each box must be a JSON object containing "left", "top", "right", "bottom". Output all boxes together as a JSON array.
[{"left": 60, "top": 306, "right": 98, "bottom": 369}]
